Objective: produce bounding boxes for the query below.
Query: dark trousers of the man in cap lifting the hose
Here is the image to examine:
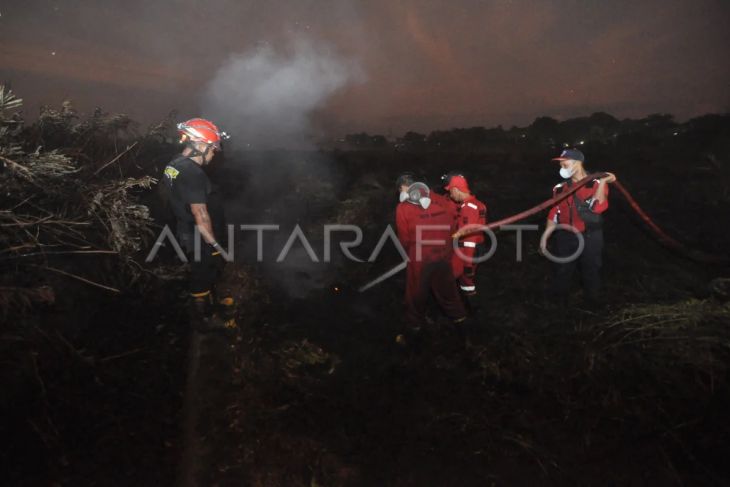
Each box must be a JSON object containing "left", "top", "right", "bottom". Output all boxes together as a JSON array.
[{"left": 550, "top": 229, "right": 603, "bottom": 300}]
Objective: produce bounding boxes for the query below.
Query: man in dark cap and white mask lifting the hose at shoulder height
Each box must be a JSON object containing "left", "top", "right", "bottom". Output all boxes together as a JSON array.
[{"left": 540, "top": 149, "right": 616, "bottom": 305}]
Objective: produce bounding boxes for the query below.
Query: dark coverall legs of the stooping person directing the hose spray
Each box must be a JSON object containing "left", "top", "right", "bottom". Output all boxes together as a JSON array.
[{"left": 406, "top": 260, "right": 466, "bottom": 328}]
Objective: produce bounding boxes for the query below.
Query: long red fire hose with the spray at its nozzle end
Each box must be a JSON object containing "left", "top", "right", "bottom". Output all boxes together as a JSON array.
[{"left": 359, "top": 173, "right": 730, "bottom": 292}]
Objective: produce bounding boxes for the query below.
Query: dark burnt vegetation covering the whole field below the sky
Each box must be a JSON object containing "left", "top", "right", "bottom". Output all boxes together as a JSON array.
[{"left": 0, "top": 88, "right": 730, "bottom": 486}]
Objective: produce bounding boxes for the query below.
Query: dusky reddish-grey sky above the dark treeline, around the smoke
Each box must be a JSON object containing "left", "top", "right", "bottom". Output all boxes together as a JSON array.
[{"left": 0, "top": 0, "right": 730, "bottom": 133}]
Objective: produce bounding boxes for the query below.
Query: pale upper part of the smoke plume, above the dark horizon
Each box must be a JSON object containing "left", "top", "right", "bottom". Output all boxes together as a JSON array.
[{"left": 203, "top": 39, "right": 362, "bottom": 149}]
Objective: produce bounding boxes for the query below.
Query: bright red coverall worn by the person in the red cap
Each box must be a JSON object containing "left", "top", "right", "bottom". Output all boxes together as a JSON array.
[{"left": 451, "top": 195, "right": 487, "bottom": 295}]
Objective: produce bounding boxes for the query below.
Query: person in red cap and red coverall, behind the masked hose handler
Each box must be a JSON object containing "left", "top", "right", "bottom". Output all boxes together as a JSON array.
[{"left": 444, "top": 174, "right": 487, "bottom": 312}]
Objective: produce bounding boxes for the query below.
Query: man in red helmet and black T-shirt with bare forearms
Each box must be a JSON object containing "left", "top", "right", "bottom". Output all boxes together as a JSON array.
[{"left": 163, "top": 118, "right": 232, "bottom": 328}]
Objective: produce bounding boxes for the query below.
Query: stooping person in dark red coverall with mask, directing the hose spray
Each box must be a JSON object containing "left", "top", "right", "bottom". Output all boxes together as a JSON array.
[{"left": 395, "top": 174, "right": 466, "bottom": 342}]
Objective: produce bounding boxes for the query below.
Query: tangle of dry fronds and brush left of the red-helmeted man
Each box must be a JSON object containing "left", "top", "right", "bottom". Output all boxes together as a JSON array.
[{"left": 0, "top": 85, "right": 168, "bottom": 304}]
